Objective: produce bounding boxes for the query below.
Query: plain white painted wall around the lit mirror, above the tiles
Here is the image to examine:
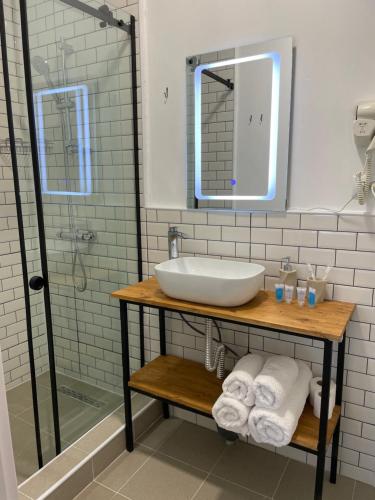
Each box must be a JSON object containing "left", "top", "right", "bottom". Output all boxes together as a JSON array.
[{"left": 141, "top": 0, "right": 375, "bottom": 212}]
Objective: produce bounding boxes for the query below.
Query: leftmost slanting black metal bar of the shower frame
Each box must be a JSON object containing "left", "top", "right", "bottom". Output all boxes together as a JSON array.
[{"left": 0, "top": 0, "right": 43, "bottom": 467}]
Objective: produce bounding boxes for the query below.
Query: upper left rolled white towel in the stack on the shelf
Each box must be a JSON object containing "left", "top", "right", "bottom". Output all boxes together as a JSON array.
[{"left": 223, "top": 354, "right": 264, "bottom": 406}]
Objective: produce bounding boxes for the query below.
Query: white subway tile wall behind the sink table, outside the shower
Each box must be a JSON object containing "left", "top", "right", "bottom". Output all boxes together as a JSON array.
[{"left": 144, "top": 210, "right": 375, "bottom": 484}]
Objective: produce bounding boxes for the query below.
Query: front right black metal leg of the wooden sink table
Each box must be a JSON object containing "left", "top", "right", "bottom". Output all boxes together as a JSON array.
[{"left": 314, "top": 340, "right": 332, "bottom": 500}]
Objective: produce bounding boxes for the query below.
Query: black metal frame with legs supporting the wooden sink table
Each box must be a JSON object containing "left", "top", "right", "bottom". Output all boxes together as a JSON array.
[{"left": 120, "top": 300, "right": 346, "bottom": 500}]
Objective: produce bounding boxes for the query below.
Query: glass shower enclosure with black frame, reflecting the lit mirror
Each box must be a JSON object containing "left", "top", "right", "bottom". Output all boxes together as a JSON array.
[{"left": 2, "top": 0, "right": 144, "bottom": 479}]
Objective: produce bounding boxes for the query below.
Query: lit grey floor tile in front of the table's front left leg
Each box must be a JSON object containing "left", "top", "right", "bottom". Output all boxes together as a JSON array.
[{"left": 120, "top": 454, "right": 206, "bottom": 500}]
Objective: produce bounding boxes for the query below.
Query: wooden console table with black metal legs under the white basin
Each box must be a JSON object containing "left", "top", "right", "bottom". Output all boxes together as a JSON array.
[{"left": 112, "top": 278, "right": 355, "bottom": 500}]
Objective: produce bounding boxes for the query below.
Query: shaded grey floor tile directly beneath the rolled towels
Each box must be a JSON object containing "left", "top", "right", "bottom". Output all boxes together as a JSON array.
[{"left": 213, "top": 442, "right": 288, "bottom": 496}]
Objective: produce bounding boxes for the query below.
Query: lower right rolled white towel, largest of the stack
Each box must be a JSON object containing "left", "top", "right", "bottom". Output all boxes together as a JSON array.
[{"left": 249, "top": 361, "right": 312, "bottom": 447}]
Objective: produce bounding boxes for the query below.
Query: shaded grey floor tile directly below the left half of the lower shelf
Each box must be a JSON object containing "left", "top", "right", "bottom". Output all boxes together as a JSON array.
[{"left": 159, "top": 422, "right": 225, "bottom": 472}]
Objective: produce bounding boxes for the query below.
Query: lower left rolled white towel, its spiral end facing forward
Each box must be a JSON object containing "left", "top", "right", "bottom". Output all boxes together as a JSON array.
[{"left": 212, "top": 394, "right": 250, "bottom": 436}]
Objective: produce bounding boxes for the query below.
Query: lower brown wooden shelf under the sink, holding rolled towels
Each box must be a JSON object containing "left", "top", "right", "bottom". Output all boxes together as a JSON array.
[{"left": 129, "top": 356, "right": 341, "bottom": 452}]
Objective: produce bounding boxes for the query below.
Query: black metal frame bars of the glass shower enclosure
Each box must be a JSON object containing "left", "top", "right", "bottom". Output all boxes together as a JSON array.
[{"left": 0, "top": 0, "right": 145, "bottom": 468}]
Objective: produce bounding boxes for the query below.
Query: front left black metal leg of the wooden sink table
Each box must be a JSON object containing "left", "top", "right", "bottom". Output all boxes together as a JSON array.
[{"left": 120, "top": 300, "right": 134, "bottom": 452}]
